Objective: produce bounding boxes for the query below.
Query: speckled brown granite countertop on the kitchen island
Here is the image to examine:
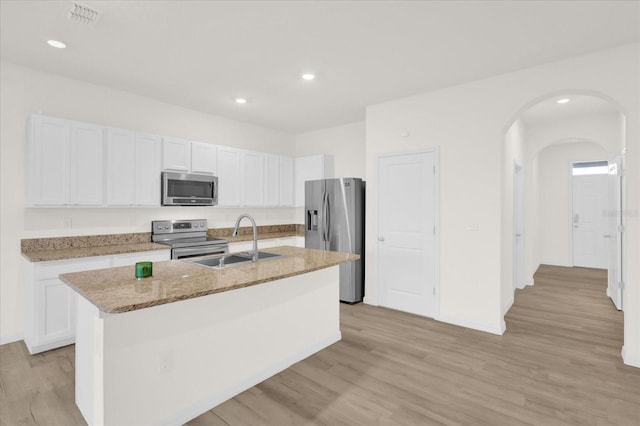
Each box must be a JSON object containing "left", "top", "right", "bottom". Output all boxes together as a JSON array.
[{"left": 60, "top": 246, "right": 360, "bottom": 314}]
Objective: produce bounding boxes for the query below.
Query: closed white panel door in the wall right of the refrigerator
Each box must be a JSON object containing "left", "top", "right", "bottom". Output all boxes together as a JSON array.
[{"left": 378, "top": 152, "right": 437, "bottom": 317}]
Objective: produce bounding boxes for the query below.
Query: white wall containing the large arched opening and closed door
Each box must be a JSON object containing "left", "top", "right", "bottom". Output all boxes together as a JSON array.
[{"left": 366, "top": 43, "right": 640, "bottom": 366}]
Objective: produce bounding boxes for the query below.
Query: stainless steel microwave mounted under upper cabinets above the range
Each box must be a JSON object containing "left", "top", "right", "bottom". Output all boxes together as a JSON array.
[{"left": 162, "top": 172, "right": 218, "bottom": 206}]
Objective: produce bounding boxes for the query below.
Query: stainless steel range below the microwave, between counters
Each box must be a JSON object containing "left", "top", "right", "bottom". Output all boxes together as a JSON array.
[{"left": 151, "top": 219, "right": 229, "bottom": 259}]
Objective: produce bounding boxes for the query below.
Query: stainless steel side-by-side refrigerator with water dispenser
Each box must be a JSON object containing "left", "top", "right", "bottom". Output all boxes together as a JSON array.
[{"left": 304, "top": 178, "right": 365, "bottom": 303}]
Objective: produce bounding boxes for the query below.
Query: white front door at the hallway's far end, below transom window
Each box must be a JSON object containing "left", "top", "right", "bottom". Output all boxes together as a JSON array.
[{"left": 572, "top": 174, "right": 609, "bottom": 269}]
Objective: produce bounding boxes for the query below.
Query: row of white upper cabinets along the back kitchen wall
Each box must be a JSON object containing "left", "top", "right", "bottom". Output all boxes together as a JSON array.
[{"left": 26, "top": 114, "right": 302, "bottom": 207}]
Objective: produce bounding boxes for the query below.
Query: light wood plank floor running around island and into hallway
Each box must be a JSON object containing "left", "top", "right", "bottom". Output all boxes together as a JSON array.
[{"left": 0, "top": 266, "right": 640, "bottom": 426}]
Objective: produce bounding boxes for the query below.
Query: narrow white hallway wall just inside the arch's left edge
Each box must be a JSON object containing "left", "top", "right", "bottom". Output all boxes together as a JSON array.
[{"left": 500, "top": 119, "right": 527, "bottom": 315}]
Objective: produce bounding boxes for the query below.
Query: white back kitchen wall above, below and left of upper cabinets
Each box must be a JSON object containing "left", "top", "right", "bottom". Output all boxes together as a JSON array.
[{"left": 0, "top": 62, "right": 295, "bottom": 343}]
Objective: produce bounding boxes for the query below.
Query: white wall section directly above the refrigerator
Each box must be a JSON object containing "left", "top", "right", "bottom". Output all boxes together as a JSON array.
[{"left": 296, "top": 121, "right": 366, "bottom": 179}]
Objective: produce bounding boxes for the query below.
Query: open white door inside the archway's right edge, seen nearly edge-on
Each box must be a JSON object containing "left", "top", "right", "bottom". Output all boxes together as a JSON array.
[{"left": 607, "top": 158, "right": 623, "bottom": 310}]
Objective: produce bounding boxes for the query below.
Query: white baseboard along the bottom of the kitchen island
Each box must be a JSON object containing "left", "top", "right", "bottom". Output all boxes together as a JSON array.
[{"left": 164, "top": 331, "right": 342, "bottom": 425}]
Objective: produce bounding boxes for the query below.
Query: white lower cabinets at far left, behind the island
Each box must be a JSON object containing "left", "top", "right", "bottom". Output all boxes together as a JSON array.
[{"left": 24, "top": 250, "right": 170, "bottom": 354}]
